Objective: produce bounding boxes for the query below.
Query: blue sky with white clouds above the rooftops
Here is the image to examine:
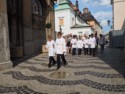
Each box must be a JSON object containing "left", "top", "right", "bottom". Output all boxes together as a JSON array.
[{"left": 71, "top": 0, "right": 112, "bottom": 34}]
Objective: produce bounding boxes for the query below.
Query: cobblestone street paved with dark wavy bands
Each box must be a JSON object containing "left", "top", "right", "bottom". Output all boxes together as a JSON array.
[{"left": 0, "top": 48, "right": 125, "bottom": 94}]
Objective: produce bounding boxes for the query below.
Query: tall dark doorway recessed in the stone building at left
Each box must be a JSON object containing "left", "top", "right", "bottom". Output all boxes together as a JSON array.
[{"left": 7, "top": 0, "right": 24, "bottom": 60}]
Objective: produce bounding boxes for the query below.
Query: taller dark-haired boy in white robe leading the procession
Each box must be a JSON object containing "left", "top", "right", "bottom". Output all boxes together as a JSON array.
[{"left": 55, "top": 32, "right": 67, "bottom": 70}]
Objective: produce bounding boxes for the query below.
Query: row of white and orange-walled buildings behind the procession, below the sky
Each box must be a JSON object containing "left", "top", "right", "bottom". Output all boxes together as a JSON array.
[{"left": 55, "top": 0, "right": 102, "bottom": 36}]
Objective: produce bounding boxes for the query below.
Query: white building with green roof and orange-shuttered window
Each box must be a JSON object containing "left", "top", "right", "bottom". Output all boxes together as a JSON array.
[{"left": 55, "top": 0, "right": 93, "bottom": 35}]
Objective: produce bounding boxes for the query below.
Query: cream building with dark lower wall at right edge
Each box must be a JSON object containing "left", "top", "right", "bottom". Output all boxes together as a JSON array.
[{"left": 110, "top": 0, "right": 125, "bottom": 48}]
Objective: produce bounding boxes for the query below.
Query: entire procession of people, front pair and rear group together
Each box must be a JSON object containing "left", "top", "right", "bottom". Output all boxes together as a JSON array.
[{"left": 46, "top": 32, "right": 105, "bottom": 69}]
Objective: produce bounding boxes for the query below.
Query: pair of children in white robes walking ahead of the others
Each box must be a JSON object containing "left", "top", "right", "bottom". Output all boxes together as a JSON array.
[{"left": 46, "top": 32, "right": 67, "bottom": 69}]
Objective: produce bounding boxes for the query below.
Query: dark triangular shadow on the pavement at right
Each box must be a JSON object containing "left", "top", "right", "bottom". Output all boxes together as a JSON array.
[{"left": 97, "top": 47, "right": 125, "bottom": 78}]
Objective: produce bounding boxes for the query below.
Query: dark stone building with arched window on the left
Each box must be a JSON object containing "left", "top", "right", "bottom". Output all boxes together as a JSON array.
[{"left": 0, "top": 0, "right": 56, "bottom": 70}]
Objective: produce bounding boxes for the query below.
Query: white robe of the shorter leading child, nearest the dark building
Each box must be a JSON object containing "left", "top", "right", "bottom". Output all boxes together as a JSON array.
[{"left": 46, "top": 40, "right": 55, "bottom": 56}]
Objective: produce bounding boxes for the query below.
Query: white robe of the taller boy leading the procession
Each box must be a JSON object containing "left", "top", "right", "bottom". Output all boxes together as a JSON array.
[{"left": 55, "top": 38, "right": 66, "bottom": 54}]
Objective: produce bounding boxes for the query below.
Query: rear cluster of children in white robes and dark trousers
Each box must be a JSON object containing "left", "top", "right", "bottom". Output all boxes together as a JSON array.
[{"left": 67, "top": 34, "right": 97, "bottom": 57}]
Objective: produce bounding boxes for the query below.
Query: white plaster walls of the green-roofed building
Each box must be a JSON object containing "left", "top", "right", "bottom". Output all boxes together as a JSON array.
[{"left": 55, "top": 9, "right": 92, "bottom": 35}]
